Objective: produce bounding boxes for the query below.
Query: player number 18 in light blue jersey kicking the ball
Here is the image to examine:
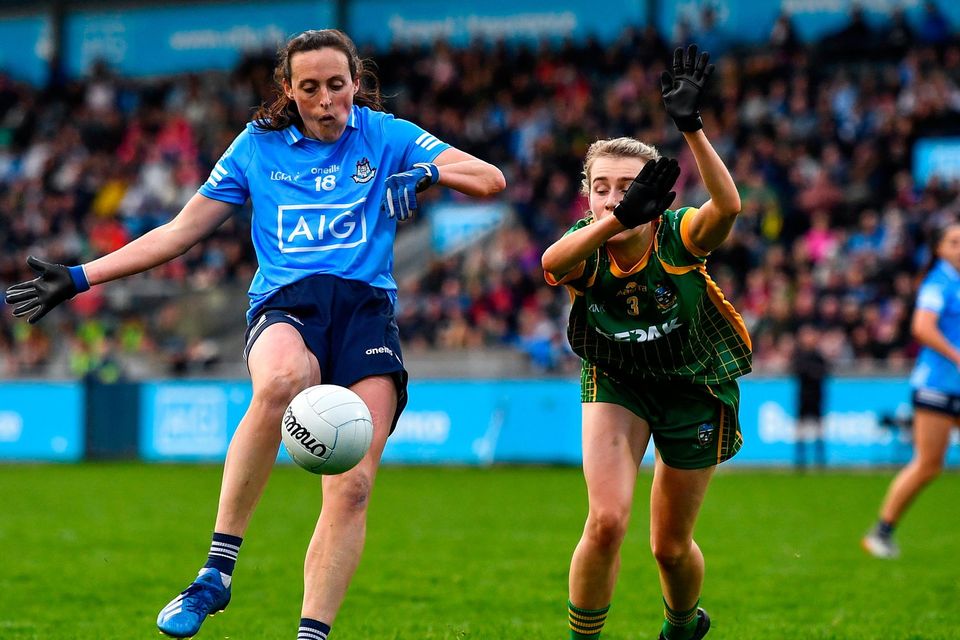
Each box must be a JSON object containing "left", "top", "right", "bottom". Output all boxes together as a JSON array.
[{"left": 6, "top": 29, "right": 505, "bottom": 640}]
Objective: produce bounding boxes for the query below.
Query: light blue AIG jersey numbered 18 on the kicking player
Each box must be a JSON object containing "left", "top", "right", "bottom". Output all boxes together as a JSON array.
[{"left": 199, "top": 106, "right": 450, "bottom": 321}]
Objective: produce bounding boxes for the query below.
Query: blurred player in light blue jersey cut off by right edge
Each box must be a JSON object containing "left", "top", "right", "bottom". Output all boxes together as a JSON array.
[{"left": 862, "top": 221, "right": 960, "bottom": 559}]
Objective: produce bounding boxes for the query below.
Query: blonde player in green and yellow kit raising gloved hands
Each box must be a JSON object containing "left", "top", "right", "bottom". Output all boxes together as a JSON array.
[{"left": 543, "top": 46, "right": 751, "bottom": 640}]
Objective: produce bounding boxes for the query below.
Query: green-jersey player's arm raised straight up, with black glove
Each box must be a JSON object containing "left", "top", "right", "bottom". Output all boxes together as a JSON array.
[{"left": 660, "top": 45, "right": 740, "bottom": 252}]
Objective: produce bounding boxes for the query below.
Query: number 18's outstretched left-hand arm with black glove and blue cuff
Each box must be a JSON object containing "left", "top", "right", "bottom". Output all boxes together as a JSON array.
[{"left": 6, "top": 194, "right": 233, "bottom": 324}]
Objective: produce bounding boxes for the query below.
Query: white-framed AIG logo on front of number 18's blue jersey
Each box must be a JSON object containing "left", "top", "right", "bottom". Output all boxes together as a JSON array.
[{"left": 277, "top": 197, "right": 367, "bottom": 253}]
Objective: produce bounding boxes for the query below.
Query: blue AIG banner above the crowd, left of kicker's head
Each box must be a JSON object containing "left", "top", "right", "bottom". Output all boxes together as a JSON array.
[{"left": 64, "top": 0, "right": 333, "bottom": 77}]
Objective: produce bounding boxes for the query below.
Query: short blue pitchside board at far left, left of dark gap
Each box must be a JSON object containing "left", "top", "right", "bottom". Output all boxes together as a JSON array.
[{"left": 0, "top": 382, "right": 84, "bottom": 462}]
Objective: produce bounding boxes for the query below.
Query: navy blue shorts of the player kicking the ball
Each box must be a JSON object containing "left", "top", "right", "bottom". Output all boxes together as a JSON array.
[{"left": 243, "top": 274, "right": 408, "bottom": 433}]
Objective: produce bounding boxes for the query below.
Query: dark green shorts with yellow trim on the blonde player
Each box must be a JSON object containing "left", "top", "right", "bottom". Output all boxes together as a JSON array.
[{"left": 580, "top": 362, "right": 743, "bottom": 469}]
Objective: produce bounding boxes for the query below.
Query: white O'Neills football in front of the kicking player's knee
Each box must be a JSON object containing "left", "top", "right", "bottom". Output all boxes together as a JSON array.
[{"left": 280, "top": 384, "right": 373, "bottom": 475}]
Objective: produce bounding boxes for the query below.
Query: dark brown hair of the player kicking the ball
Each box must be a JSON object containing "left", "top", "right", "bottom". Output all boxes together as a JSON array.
[{"left": 253, "top": 29, "right": 383, "bottom": 131}]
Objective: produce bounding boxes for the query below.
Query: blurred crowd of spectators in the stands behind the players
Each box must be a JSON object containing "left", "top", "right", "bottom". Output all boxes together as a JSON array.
[{"left": 0, "top": 3, "right": 960, "bottom": 377}]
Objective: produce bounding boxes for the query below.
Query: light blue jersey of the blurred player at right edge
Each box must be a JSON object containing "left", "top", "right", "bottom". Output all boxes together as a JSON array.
[{"left": 910, "top": 260, "right": 960, "bottom": 395}]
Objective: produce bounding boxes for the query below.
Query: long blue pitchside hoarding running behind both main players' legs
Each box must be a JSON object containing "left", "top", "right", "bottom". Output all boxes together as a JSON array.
[{"left": 133, "top": 377, "right": 960, "bottom": 466}]
